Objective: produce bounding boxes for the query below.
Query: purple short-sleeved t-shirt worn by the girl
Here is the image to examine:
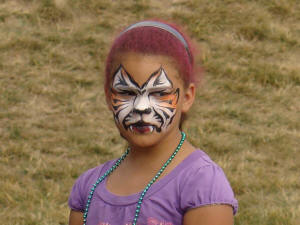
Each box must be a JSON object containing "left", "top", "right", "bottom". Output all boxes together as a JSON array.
[{"left": 69, "top": 150, "right": 238, "bottom": 225}]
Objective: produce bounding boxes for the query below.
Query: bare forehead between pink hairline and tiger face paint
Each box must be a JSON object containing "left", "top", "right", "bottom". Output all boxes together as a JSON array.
[{"left": 117, "top": 52, "right": 182, "bottom": 87}]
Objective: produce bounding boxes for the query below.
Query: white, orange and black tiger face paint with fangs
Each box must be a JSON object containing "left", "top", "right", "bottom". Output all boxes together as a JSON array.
[{"left": 111, "top": 65, "right": 179, "bottom": 133}]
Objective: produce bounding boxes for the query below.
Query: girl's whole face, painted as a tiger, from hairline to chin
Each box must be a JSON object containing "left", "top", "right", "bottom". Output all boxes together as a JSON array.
[{"left": 109, "top": 53, "right": 192, "bottom": 149}]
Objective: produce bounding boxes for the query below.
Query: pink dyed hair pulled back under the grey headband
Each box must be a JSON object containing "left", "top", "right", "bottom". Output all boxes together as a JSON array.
[{"left": 104, "top": 20, "right": 201, "bottom": 94}]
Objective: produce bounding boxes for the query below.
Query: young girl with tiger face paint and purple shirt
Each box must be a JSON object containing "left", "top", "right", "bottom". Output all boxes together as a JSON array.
[{"left": 69, "top": 21, "right": 237, "bottom": 225}]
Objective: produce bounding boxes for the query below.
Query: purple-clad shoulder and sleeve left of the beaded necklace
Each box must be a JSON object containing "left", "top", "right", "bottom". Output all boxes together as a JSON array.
[{"left": 68, "top": 160, "right": 114, "bottom": 211}]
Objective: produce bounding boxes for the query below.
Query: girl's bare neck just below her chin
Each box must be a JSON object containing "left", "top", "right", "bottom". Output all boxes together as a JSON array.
[{"left": 128, "top": 129, "right": 181, "bottom": 168}]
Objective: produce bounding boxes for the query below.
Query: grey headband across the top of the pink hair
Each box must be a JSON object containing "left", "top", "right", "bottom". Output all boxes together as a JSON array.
[{"left": 120, "top": 21, "right": 192, "bottom": 62}]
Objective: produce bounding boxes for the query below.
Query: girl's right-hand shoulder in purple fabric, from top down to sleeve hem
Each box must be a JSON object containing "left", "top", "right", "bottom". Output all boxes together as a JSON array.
[{"left": 180, "top": 150, "right": 237, "bottom": 213}]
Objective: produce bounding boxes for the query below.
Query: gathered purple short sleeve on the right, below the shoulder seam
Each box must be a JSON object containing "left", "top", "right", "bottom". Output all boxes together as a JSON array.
[{"left": 181, "top": 164, "right": 238, "bottom": 214}]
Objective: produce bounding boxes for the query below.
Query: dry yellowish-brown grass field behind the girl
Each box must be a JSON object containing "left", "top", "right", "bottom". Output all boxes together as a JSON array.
[{"left": 0, "top": 0, "right": 300, "bottom": 225}]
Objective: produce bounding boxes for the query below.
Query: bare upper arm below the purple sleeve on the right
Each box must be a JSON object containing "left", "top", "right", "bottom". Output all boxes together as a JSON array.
[{"left": 183, "top": 205, "right": 233, "bottom": 225}]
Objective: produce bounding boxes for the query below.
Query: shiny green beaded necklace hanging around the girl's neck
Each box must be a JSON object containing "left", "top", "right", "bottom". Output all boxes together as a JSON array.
[{"left": 83, "top": 132, "right": 186, "bottom": 225}]
